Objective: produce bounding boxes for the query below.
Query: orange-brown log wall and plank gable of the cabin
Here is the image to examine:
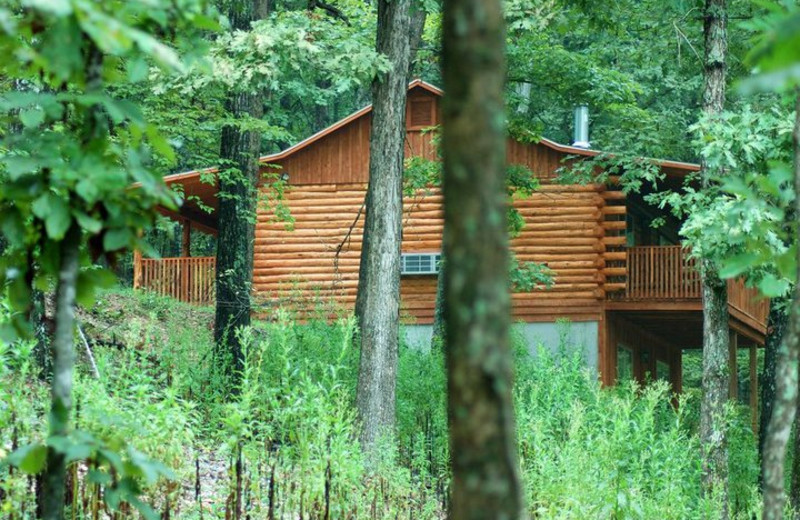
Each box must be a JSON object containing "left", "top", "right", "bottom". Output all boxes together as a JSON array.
[{"left": 253, "top": 88, "right": 608, "bottom": 324}]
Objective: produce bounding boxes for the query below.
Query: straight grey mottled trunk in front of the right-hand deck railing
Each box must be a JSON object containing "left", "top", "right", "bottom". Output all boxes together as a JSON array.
[{"left": 700, "top": 0, "right": 730, "bottom": 518}]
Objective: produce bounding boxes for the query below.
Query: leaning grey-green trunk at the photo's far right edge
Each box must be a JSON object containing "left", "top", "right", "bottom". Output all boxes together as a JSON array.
[{"left": 761, "top": 89, "right": 800, "bottom": 520}]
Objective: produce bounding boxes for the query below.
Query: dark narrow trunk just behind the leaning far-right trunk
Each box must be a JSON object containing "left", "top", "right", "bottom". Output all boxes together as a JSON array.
[{"left": 758, "top": 298, "right": 789, "bottom": 492}]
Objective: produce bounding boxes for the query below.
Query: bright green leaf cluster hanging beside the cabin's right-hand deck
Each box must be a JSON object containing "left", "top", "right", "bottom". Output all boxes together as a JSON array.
[{"left": 664, "top": 104, "right": 796, "bottom": 297}]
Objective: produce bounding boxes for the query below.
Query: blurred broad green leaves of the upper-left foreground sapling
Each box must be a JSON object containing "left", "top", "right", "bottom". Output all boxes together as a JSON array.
[{"left": 0, "top": 0, "right": 216, "bottom": 340}]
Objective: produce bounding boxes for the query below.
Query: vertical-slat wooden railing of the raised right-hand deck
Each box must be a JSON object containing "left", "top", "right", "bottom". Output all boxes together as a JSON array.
[{"left": 615, "top": 246, "right": 769, "bottom": 324}]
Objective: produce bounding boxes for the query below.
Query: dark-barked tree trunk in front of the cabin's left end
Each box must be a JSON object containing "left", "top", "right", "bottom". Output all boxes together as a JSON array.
[{"left": 214, "top": 0, "right": 269, "bottom": 388}]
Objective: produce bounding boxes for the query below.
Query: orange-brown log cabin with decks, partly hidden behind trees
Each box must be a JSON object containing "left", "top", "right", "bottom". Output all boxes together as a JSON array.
[{"left": 134, "top": 80, "right": 768, "bottom": 417}]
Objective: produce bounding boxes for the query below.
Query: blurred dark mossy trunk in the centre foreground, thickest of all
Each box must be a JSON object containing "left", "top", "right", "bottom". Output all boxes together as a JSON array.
[{"left": 442, "top": 0, "right": 523, "bottom": 520}]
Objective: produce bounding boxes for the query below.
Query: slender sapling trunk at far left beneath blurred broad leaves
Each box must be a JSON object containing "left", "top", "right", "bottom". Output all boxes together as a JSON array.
[{"left": 41, "top": 225, "right": 81, "bottom": 520}]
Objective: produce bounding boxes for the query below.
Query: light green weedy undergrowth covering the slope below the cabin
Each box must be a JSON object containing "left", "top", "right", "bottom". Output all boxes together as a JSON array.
[{"left": 0, "top": 292, "right": 759, "bottom": 519}]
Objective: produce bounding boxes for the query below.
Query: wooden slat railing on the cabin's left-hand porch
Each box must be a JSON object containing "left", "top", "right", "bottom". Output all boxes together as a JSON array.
[{"left": 133, "top": 256, "right": 216, "bottom": 305}]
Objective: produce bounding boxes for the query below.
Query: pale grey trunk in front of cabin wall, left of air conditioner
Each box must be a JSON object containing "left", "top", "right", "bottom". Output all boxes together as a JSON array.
[{"left": 356, "top": 0, "right": 411, "bottom": 466}]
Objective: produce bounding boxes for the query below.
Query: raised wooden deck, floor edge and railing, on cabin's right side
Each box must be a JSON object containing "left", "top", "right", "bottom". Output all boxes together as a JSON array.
[{"left": 609, "top": 246, "right": 769, "bottom": 333}]
